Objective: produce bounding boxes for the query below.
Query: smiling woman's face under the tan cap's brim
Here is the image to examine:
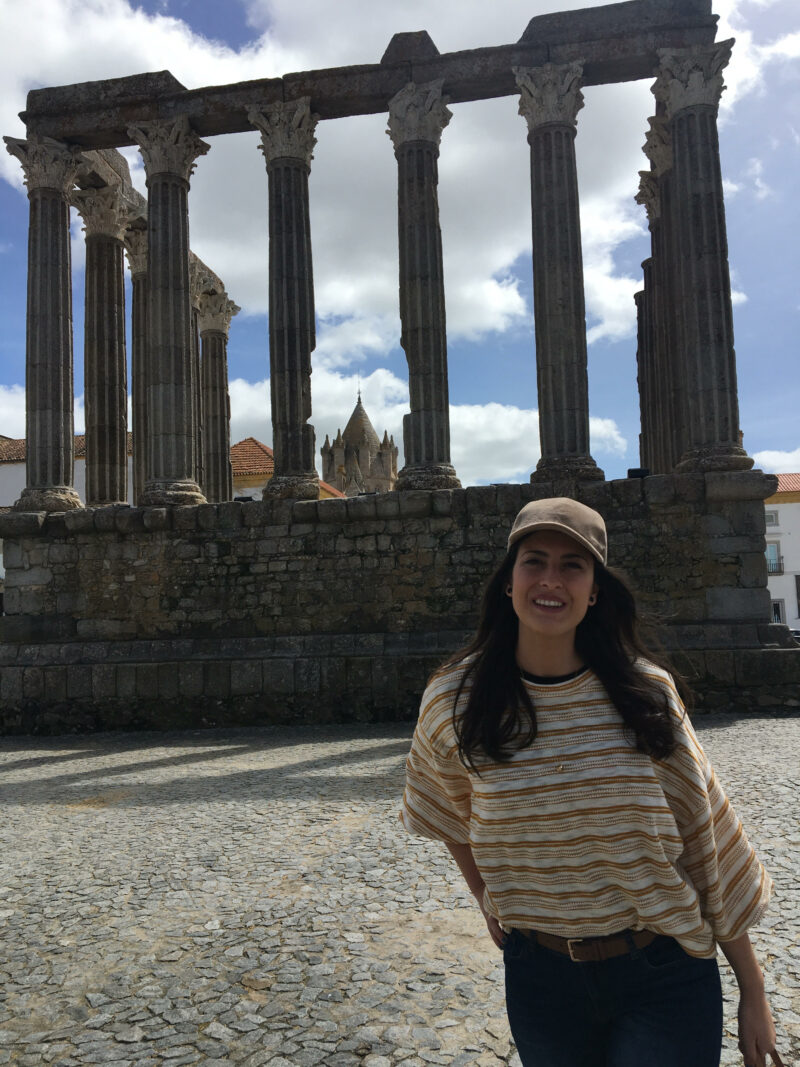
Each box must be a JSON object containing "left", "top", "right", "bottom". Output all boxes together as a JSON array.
[{"left": 510, "top": 530, "right": 597, "bottom": 640}]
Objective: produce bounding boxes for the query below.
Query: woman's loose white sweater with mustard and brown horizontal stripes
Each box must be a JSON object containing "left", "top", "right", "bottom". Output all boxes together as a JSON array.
[{"left": 400, "top": 663, "right": 771, "bottom": 957}]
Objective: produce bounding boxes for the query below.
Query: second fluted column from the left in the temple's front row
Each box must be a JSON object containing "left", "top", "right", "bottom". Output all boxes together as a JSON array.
[{"left": 128, "top": 115, "right": 208, "bottom": 505}]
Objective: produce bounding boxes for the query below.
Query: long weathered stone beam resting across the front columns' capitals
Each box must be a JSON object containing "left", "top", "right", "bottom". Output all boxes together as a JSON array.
[{"left": 21, "top": 0, "right": 717, "bottom": 148}]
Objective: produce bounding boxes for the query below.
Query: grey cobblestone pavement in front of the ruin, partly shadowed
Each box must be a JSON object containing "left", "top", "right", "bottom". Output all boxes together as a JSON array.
[{"left": 0, "top": 718, "right": 800, "bottom": 1067}]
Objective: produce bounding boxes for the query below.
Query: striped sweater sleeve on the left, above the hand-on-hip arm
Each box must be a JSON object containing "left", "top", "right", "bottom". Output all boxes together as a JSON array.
[{"left": 400, "top": 678, "right": 471, "bottom": 844}]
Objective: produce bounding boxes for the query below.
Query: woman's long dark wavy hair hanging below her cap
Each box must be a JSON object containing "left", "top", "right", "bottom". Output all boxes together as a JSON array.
[{"left": 452, "top": 542, "right": 689, "bottom": 770}]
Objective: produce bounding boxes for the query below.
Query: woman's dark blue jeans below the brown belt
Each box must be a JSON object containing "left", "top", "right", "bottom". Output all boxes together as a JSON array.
[{"left": 503, "top": 930, "right": 722, "bottom": 1067}]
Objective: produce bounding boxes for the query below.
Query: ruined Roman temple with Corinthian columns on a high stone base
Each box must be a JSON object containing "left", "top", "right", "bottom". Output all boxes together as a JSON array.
[{"left": 0, "top": 0, "right": 800, "bottom": 730}]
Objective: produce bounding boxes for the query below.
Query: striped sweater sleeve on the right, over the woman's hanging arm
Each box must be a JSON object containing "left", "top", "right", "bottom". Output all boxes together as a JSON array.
[{"left": 658, "top": 680, "right": 772, "bottom": 941}]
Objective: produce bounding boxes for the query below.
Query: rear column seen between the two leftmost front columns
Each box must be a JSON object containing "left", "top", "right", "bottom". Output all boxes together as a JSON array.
[{"left": 73, "top": 186, "right": 130, "bottom": 506}]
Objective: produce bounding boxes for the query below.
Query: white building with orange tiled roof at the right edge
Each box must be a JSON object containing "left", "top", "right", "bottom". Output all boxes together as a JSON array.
[{"left": 764, "top": 474, "right": 800, "bottom": 631}]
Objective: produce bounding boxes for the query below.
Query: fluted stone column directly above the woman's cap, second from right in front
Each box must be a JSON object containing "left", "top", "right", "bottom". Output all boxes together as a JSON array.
[{"left": 514, "top": 63, "right": 603, "bottom": 481}]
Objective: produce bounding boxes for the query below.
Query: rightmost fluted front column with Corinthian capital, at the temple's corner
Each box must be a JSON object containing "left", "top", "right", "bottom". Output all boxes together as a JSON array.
[{"left": 653, "top": 41, "right": 753, "bottom": 472}]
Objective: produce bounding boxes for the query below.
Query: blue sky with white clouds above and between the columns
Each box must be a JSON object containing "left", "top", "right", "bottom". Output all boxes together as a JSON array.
[{"left": 0, "top": 0, "right": 800, "bottom": 484}]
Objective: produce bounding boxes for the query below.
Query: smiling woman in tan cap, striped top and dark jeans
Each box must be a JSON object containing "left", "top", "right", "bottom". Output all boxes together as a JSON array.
[{"left": 402, "top": 498, "right": 780, "bottom": 1067}]
